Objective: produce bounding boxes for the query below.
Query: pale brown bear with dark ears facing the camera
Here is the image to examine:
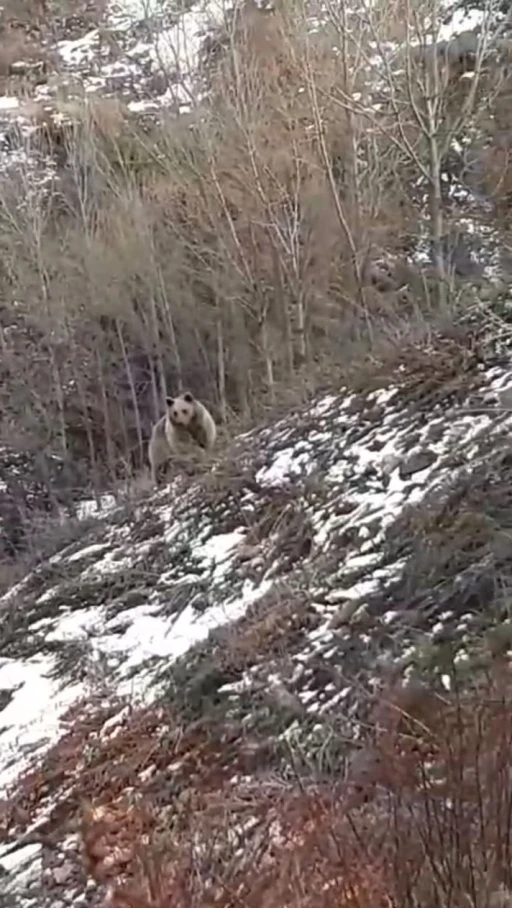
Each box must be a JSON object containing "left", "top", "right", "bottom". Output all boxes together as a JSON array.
[{"left": 148, "top": 391, "right": 217, "bottom": 485}]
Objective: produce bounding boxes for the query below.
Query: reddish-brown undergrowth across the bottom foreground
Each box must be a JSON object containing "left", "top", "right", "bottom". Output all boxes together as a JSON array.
[{"left": 3, "top": 665, "right": 512, "bottom": 908}]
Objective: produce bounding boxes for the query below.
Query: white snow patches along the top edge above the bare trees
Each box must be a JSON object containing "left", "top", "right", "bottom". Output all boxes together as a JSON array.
[{"left": 0, "top": 0, "right": 496, "bottom": 127}]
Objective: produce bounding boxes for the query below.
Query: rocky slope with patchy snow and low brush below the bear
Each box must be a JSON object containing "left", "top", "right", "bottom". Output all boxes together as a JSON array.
[{"left": 0, "top": 330, "right": 512, "bottom": 906}]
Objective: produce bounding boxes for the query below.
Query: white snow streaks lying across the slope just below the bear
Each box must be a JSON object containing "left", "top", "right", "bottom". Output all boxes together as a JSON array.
[{"left": 0, "top": 352, "right": 512, "bottom": 885}]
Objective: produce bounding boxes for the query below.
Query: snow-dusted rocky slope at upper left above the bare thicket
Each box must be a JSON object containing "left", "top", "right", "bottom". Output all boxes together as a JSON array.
[{"left": 0, "top": 0, "right": 227, "bottom": 172}]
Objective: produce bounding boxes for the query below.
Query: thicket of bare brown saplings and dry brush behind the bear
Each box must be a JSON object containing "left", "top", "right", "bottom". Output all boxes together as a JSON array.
[{"left": 0, "top": 0, "right": 508, "bottom": 510}]
